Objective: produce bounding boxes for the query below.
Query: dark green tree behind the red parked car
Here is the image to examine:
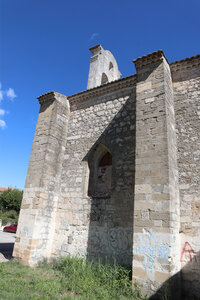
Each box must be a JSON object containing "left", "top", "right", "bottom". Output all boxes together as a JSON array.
[{"left": 0, "top": 189, "right": 23, "bottom": 213}]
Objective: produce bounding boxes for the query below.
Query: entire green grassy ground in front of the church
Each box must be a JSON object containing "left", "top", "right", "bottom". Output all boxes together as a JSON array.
[{"left": 0, "top": 257, "right": 145, "bottom": 300}]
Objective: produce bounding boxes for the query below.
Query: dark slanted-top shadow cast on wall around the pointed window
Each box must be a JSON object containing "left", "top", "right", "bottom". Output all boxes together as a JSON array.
[{"left": 84, "top": 88, "right": 135, "bottom": 266}]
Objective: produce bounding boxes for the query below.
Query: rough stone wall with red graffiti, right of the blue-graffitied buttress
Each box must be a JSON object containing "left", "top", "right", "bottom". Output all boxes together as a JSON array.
[{"left": 171, "top": 57, "right": 200, "bottom": 299}]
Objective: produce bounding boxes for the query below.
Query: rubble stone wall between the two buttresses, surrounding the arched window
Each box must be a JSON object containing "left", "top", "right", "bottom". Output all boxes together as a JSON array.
[{"left": 50, "top": 81, "right": 135, "bottom": 265}]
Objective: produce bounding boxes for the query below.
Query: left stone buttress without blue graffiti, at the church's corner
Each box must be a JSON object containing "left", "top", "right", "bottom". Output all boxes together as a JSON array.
[{"left": 13, "top": 92, "right": 69, "bottom": 266}]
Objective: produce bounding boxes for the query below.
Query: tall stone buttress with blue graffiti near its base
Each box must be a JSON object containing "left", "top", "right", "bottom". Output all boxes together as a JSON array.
[{"left": 132, "top": 51, "right": 180, "bottom": 293}]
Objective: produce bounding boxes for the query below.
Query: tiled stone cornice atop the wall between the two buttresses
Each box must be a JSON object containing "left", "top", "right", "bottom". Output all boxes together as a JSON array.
[{"left": 67, "top": 74, "right": 136, "bottom": 104}]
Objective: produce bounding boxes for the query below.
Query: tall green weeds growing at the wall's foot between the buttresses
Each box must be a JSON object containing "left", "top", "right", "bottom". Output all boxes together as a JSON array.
[{"left": 54, "top": 257, "right": 144, "bottom": 300}]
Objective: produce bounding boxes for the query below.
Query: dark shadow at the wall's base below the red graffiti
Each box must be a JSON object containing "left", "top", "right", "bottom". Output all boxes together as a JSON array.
[{"left": 149, "top": 251, "right": 200, "bottom": 300}]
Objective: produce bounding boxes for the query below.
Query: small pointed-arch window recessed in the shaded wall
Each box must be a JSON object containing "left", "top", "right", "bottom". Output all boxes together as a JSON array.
[{"left": 96, "top": 152, "right": 112, "bottom": 196}]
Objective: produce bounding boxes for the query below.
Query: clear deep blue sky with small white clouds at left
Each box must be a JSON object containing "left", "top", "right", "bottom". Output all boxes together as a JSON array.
[{"left": 0, "top": 0, "right": 200, "bottom": 189}]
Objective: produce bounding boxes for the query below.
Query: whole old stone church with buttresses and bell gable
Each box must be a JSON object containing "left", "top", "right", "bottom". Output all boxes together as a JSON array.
[{"left": 13, "top": 45, "right": 200, "bottom": 299}]
